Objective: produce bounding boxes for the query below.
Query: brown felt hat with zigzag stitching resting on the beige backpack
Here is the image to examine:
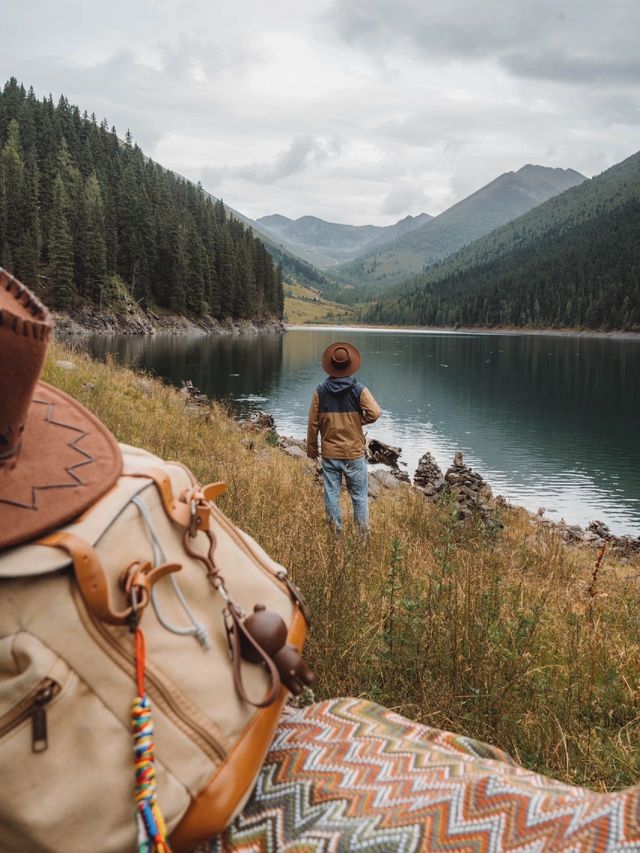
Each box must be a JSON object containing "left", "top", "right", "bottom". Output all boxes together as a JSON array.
[{"left": 0, "top": 267, "right": 122, "bottom": 549}]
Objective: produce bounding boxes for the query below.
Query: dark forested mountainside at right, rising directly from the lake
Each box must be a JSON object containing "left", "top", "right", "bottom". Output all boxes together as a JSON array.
[{"left": 363, "top": 152, "right": 640, "bottom": 331}]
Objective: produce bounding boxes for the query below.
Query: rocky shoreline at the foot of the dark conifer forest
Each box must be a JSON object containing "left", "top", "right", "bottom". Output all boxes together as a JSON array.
[{"left": 54, "top": 303, "right": 285, "bottom": 338}]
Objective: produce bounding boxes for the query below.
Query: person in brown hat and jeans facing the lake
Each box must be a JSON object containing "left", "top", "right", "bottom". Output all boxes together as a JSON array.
[{"left": 307, "top": 341, "right": 380, "bottom": 531}]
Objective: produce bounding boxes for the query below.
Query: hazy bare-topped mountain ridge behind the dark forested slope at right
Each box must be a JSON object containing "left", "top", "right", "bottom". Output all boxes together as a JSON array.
[{"left": 332, "top": 165, "right": 586, "bottom": 292}]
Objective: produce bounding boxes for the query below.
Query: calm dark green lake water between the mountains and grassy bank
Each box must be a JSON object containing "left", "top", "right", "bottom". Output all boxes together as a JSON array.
[{"left": 83, "top": 328, "right": 640, "bottom": 535}]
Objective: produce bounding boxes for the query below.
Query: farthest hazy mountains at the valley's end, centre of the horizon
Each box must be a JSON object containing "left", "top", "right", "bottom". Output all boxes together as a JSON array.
[{"left": 255, "top": 213, "right": 432, "bottom": 269}]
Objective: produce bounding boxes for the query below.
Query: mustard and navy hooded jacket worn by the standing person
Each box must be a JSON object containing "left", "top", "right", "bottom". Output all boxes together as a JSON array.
[{"left": 307, "top": 376, "right": 380, "bottom": 459}]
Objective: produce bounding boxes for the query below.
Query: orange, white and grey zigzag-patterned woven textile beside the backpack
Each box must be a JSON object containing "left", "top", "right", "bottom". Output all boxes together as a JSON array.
[{"left": 198, "top": 699, "right": 640, "bottom": 853}]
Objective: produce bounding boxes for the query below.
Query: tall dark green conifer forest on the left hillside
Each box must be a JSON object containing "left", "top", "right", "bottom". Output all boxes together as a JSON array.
[{"left": 0, "top": 78, "right": 284, "bottom": 319}]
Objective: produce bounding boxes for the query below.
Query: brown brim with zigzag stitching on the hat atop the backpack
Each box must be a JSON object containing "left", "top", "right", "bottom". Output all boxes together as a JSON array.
[{"left": 0, "top": 382, "right": 122, "bottom": 549}]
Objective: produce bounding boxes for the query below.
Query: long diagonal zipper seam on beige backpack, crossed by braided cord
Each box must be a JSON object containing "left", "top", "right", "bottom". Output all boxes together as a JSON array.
[{"left": 71, "top": 584, "right": 227, "bottom": 763}]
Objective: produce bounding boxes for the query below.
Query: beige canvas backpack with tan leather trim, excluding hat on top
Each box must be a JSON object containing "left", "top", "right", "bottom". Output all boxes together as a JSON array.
[{"left": 0, "top": 446, "right": 310, "bottom": 853}]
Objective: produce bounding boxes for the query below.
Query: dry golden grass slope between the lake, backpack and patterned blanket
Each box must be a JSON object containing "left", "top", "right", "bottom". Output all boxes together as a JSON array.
[{"left": 44, "top": 345, "right": 640, "bottom": 788}]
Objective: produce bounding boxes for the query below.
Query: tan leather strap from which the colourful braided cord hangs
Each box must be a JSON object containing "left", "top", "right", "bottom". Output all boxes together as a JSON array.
[{"left": 38, "top": 531, "right": 182, "bottom": 625}]
